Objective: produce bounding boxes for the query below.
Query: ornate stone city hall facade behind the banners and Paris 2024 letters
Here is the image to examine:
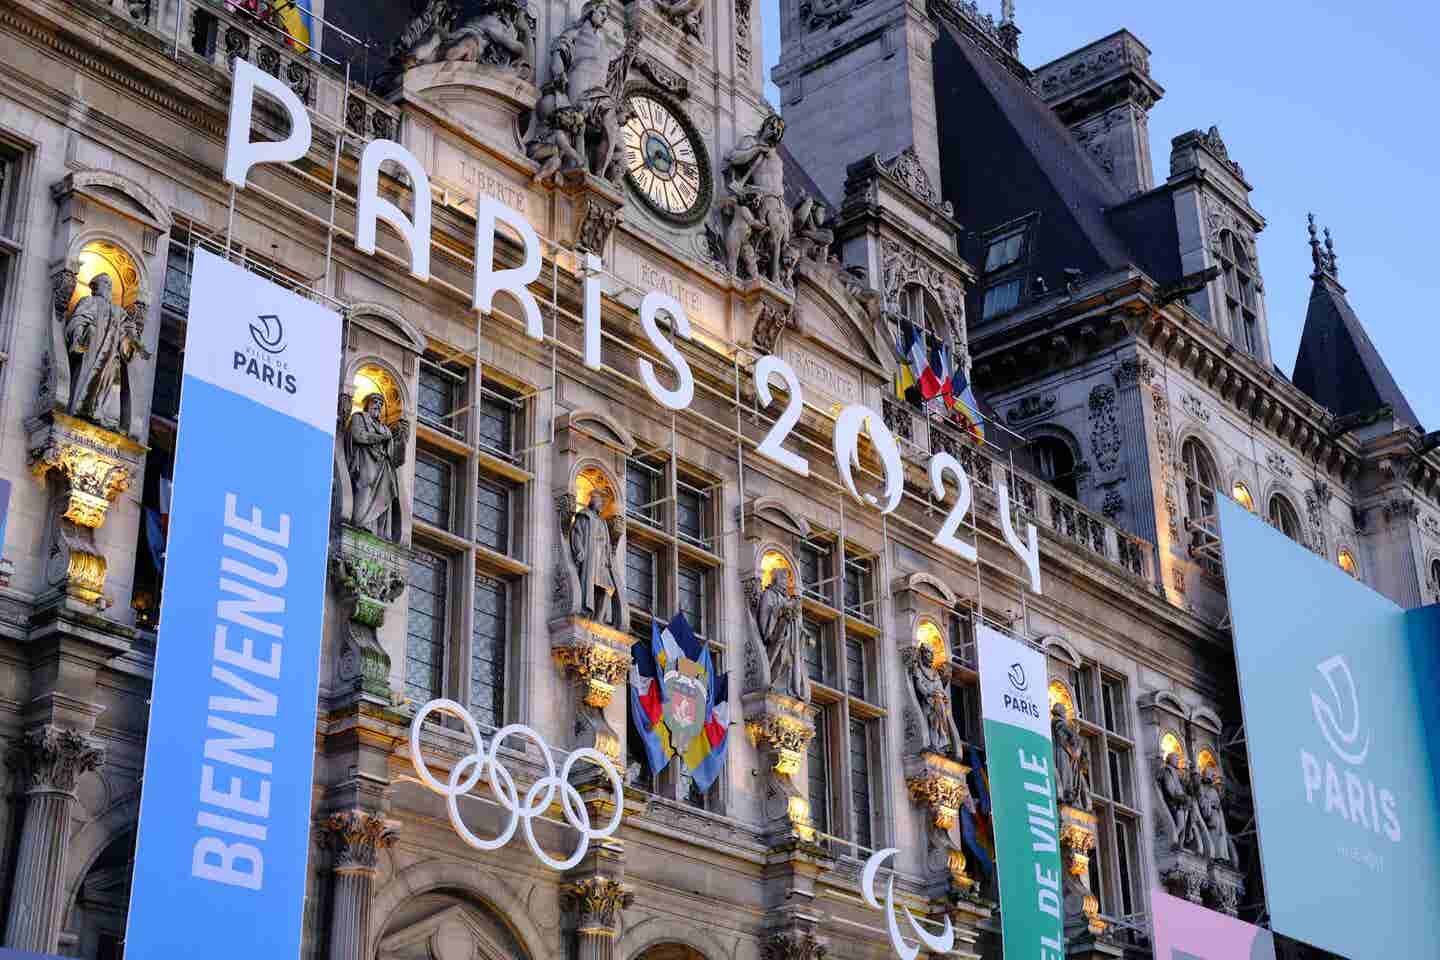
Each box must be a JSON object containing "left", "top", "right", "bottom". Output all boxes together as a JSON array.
[{"left": 0, "top": 0, "right": 1440, "bottom": 960}]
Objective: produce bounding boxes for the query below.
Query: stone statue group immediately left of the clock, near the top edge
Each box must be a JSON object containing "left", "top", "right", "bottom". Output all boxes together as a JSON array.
[{"left": 526, "top": 0, "right": 639, "bottom": 183}]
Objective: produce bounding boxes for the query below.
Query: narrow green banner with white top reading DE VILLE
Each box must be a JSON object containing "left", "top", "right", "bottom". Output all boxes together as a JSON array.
[{"left": 976, "top": 626, "right": 1066, "bottom": 960}]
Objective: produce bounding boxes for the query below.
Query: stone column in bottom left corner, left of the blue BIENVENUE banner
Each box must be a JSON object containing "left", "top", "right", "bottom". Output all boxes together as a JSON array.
[{"left": 4, "top": 724, "right": 105, "bottom": 953}]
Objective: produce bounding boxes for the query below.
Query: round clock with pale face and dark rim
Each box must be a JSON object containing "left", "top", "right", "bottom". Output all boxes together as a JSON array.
[{"left": 624, "top": 92, "right": 713, "bottom": 225}]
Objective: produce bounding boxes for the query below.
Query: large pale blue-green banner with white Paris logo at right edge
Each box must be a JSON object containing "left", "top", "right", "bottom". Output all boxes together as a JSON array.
[{"left": 1220, "top": 498, "right": 1440, "bottom": 960}]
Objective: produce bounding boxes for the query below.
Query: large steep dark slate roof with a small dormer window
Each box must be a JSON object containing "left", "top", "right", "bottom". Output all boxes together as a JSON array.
[{"left": 935, "top": 20, "right": 1140, "bottom": 286}]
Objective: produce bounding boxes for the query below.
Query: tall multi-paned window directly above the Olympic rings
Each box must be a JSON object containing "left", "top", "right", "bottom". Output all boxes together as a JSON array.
[{"left": 406, "top": 359, "right": 531, "bottom": 727}]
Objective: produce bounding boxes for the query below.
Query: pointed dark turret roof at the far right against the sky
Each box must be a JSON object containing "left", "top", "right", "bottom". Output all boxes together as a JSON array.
[{"left": 1292, "top": 275, "right": 1420, "bottom": 427}]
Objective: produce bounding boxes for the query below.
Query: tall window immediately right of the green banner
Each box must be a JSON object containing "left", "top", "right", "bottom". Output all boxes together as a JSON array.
[{"left": 1051, "top": 659, "right": 1143, "bottom": 917}]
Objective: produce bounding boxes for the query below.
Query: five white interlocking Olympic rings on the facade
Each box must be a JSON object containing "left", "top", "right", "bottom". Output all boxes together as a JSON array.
[{"left": 410, "top": 699, "right": 625, "bottom": 871}]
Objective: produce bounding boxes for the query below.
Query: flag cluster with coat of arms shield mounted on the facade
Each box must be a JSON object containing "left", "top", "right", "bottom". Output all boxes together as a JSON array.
[{"left": 629, "top": 613, "right": 729, "bottom": 792}]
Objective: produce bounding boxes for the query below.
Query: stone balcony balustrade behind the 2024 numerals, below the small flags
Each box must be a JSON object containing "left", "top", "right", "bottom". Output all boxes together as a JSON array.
[{"left": 884, "top": 400, "right": 1155, "bottom": 587}]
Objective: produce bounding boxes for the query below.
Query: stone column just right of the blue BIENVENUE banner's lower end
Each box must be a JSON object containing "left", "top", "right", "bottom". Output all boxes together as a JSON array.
[{"left": 320, "top": 810, "right": 396, "bottom": 960}]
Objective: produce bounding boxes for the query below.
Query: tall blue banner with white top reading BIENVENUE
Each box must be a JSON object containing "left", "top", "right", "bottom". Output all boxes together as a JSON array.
[{"left": 125, "top": 250, "right": 340, "bottom": 960}]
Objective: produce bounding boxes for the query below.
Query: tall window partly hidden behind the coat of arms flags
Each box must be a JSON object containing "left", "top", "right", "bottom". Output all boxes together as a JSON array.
[{"left": 624, "top": 456, "right": 726, "bottom": 810}]
